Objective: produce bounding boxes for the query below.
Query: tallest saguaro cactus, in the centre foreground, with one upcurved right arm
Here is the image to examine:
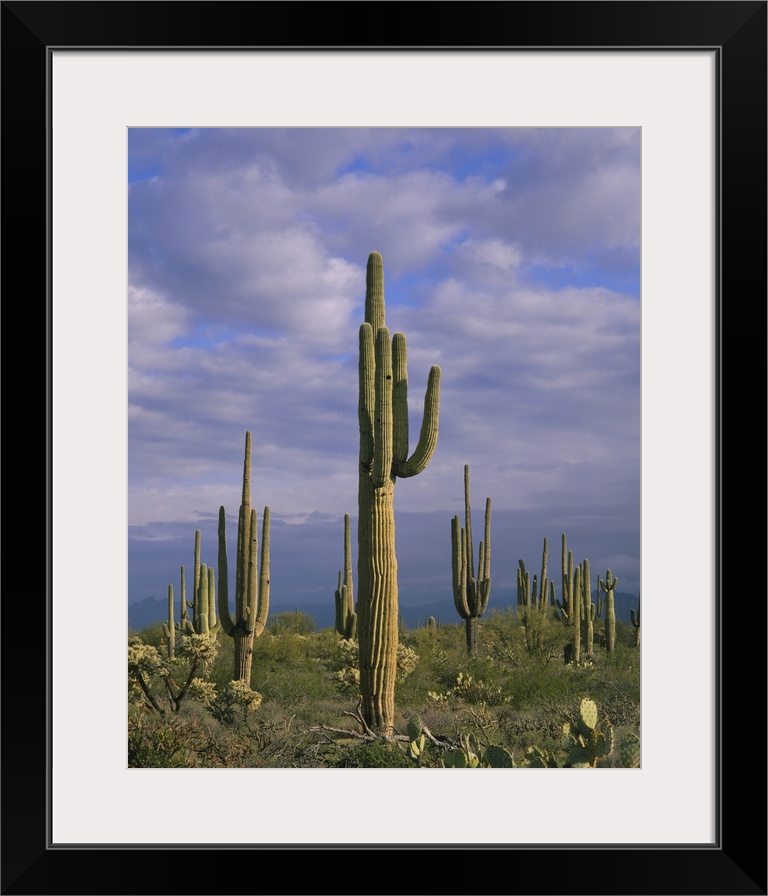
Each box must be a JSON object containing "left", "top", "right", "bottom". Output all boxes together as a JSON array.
[{"left": 357, "top": 252, "right": 440, "bottom": 735}]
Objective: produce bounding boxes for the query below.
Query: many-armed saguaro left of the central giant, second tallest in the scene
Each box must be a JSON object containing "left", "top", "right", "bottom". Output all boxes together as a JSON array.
[{"left": 217, "top": 432, "right": 269, "bottom": 687}]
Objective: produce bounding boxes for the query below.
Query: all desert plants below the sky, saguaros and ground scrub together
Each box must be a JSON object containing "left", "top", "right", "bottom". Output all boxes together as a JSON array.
[{"left": 134, "top": 252, "right": 640, "bottom": 768}]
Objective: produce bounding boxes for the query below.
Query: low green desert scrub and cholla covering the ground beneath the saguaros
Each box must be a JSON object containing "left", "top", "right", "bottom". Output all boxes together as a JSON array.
[{"left": 128, "top": 609, "right": 640, "bottom": 768}]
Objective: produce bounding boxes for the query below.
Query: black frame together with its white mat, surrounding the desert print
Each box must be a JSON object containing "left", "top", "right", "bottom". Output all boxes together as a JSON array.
[{"left": 9, "top": 2, "right": 767, "bottom": 896}]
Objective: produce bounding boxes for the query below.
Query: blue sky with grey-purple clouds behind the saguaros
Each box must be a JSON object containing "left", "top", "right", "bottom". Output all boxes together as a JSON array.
[{"left": 128, "top": 128, "right": 640, "bottom": 621}]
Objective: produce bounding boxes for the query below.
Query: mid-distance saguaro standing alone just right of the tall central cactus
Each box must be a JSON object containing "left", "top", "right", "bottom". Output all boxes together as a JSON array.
[{"left": 451, "top": 464, "right": 491, "bottom": 656}]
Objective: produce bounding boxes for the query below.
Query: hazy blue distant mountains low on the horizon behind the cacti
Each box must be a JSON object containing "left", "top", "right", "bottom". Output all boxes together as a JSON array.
[{"left": 128, "top": 591, "right": 638, "bottom": 631}]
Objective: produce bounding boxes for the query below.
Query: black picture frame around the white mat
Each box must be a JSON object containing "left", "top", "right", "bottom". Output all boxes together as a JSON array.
[{"left": 0, "top": 0, "right": 768, "bottom": 896}]
